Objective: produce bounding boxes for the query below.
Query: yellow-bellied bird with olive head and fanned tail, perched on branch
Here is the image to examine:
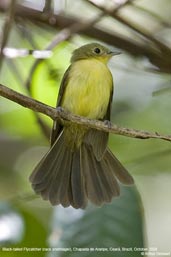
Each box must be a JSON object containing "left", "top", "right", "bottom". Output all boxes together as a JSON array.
[{"left": 29, "top": 43, "right": 134, "bottom": 209}]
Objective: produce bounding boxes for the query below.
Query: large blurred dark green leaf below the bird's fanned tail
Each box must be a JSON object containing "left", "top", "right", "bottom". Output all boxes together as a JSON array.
[{"left": 51, "top": 186, "right": 144, "bottom": 257}]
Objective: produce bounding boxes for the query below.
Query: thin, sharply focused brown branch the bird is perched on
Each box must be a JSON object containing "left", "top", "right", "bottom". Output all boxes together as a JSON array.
[{"left": 0, "top": 84, "right": 171, "bottom": 142}]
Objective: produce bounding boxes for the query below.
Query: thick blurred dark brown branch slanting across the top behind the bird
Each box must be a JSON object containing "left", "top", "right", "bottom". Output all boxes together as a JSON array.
[{"left": 0, "top": 1, "right": 171, "bottom": 74}]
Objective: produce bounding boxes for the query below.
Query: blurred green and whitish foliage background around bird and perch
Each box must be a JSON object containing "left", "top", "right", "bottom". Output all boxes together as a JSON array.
[{"left": 0, "top": 0, "right": 171, "bottom": 257}]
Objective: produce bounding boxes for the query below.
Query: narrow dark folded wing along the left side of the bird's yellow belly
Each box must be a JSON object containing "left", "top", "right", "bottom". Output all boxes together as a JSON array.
[{"left": 51, "top": 65, "right": 71, "bottom": 146}]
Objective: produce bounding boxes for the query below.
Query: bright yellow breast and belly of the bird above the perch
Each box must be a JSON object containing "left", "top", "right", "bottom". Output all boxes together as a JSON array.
[{"left": 61, "top": 59, "right": 113, "bottom": 119}]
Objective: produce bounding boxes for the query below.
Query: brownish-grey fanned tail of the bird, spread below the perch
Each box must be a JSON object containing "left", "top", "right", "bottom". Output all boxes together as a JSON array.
[{"left": 30, "top": 131, "right": 133, "bottom": 209}]
